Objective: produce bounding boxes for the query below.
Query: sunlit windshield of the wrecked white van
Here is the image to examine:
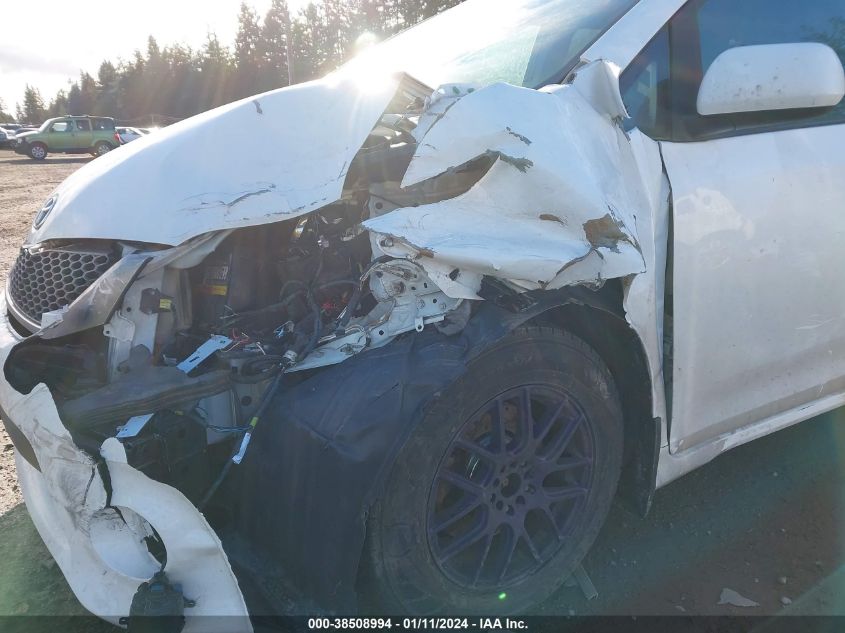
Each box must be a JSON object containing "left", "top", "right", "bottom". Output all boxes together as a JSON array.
[{"left": 341, "top": 0, "right": 638, "bottom": 88}]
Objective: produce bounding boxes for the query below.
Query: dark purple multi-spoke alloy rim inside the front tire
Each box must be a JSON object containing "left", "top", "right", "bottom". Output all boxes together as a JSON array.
[{"left": 427, "top": 385, "right": 596, "bottom": 589}]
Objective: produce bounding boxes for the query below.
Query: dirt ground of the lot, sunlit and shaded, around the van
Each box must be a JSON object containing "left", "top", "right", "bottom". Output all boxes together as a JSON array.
[{"left": 0, "top": 152, "right": 845, "bottom": 633}]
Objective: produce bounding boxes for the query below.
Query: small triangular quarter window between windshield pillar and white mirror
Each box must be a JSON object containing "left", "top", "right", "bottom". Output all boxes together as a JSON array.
[{"left": 619, "top": 27, "right": 670, "bottom": 138}]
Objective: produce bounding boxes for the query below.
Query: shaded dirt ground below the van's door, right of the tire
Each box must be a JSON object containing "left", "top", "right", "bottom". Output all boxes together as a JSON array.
[{"left": 542, "top": 409, "right": 845, "bottom": 616}]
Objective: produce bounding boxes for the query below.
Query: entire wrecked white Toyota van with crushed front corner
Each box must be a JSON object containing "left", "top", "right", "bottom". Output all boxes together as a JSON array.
[{"left": 0, "top": 0, "right": 845, "bottom": 630}]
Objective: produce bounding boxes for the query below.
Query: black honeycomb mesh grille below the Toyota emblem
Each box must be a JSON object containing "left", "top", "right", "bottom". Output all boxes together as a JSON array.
[{"left": 9, "top": 250, "right": 117, "bottom": 323}]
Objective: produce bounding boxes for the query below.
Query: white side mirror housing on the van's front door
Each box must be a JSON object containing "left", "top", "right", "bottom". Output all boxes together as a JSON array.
[{"left": 697, "top": 42, "right": 845, "bottom": 115}]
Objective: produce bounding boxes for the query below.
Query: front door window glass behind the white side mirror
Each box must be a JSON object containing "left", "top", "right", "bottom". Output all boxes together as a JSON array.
[{"left": 673, "top": 0, "right": 845, "bottom": 127}]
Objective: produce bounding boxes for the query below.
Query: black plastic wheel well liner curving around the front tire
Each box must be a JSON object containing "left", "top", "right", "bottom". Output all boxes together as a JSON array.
[{"left": 224, "top": 282, "right": 650, "bottom": 612}]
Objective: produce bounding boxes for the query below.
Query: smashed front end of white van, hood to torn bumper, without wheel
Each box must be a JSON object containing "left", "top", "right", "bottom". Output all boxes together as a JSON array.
[{"left": 0, "top": 54, "right": 666, "bottom": 631}]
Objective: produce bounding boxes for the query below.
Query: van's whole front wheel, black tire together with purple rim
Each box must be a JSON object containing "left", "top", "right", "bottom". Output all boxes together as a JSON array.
[{"left": 362, "top": 327, "right": 623, "bottom": 614}]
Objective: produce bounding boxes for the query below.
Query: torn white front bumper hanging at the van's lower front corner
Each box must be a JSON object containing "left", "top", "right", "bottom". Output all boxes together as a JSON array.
[{"left": 0, "top": 297, "right": 252, "bottom": 632}]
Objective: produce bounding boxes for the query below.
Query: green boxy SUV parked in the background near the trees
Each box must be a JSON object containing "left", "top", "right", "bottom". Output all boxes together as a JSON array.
[{"left": 15, "top": 116, "right": 120, "bottom": 160}]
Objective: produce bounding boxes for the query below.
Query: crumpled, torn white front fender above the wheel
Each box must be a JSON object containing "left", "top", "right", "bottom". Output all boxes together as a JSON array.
[{"left": 364, "top": 61, "right": 649, "bottom": 297}]
